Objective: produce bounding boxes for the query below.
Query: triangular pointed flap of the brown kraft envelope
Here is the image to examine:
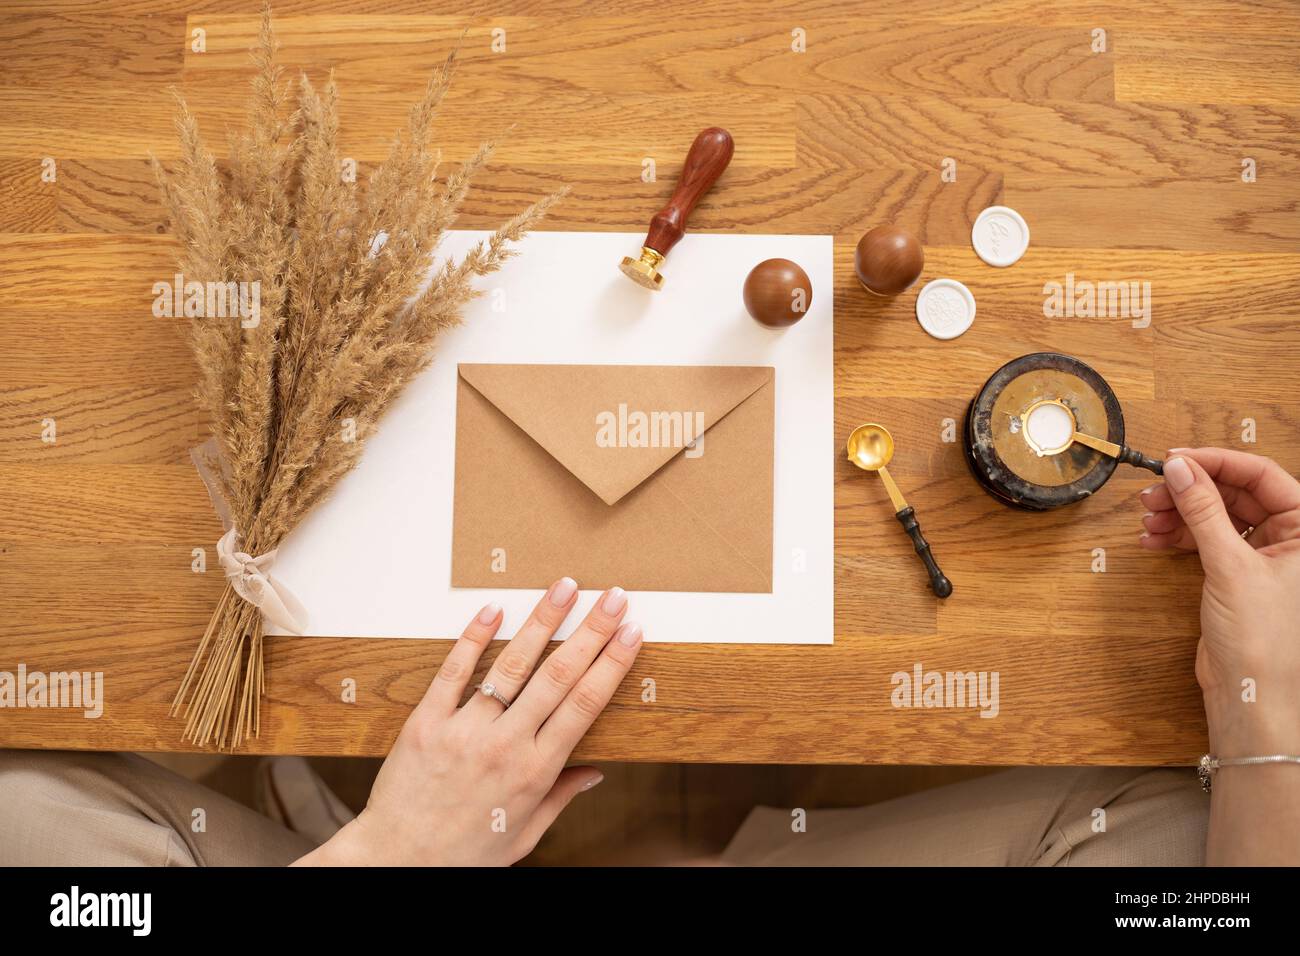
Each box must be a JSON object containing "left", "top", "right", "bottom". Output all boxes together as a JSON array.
[{"left": 459, "top": 364, "right": 774, "bottom": 505}]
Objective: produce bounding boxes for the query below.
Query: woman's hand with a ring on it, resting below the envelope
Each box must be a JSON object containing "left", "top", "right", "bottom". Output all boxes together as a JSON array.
[{"left": 299, "top": 578, "right": 641, "bottom": 866}]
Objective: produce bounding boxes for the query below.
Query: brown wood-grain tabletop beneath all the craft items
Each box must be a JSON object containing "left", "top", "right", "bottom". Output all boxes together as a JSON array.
[{"left": 0, "top": 0, "right": 1300, "bottom": 763}]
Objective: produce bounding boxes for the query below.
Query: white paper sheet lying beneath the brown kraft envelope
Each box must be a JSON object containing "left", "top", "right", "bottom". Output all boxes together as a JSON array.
[{"left": 270, "top": 232, "right": 836, "bottom": 644}]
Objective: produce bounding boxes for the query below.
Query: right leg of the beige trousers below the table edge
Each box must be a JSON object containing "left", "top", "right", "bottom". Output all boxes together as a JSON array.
[{"left": 724, "top": 767, "right": 1210, "bottom": 866}]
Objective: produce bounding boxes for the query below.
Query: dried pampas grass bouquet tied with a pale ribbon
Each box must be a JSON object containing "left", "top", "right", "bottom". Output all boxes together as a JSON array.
[{"left": 155, "top": 10, "right": 560, "bottom": 749}]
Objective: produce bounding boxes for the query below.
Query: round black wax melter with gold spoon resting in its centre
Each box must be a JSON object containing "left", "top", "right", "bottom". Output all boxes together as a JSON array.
[{"left": 963, "top": 352, "right": 1164, "bottom": 511}]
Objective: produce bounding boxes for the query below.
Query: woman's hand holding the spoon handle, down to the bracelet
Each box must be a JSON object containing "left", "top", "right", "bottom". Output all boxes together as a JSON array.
[{"left": 1141, "top": 447, "right": 1300, "bottom": 775}]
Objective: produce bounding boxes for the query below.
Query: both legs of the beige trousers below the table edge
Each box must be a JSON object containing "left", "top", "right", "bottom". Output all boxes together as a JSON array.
[{"left": 0, "top": 750, "right": 1209, "bottom": 866}]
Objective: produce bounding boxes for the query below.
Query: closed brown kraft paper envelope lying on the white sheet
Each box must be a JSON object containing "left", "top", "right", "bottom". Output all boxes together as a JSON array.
[{"left": 451, "top": 364, "right": 776, "bottom": 593}]
